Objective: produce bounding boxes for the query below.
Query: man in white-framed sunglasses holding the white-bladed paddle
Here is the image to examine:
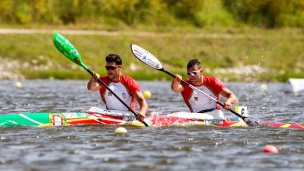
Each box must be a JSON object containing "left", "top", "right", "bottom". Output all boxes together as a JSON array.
[{"left": 171, "top": 59, "right": 245, "bottom": 124}]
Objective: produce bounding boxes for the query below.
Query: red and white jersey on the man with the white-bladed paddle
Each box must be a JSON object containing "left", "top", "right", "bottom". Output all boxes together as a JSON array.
[{"left": 181, "top": 76, "right": 226, "bottom": 112}]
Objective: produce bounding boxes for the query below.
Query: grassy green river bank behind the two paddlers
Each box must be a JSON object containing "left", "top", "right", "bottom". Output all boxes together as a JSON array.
[{"left": 0, "top": 27, "right": 304, "bottom": 82}]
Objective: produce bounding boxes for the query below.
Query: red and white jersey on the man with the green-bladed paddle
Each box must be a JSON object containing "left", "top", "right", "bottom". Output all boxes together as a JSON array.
[{"left": 99, "top": 75, "right": 141, "bottom": 111}]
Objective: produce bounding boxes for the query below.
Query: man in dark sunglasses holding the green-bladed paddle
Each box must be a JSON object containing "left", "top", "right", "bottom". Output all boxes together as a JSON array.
[{"left": 87, "top": 54, "right": 148, "bottom": 121}]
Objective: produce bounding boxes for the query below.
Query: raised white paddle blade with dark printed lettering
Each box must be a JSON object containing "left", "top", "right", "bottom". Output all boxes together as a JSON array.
[{"left": 131, "top": 44, "right": 163, "bottom": 70}]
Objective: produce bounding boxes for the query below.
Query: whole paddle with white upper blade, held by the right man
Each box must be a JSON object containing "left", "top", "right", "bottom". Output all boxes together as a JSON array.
[{"left": 130, "top": 44, "right": 260, "bottom": 126}]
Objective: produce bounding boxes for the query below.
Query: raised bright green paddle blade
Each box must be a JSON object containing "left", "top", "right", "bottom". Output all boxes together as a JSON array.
[{"left": 53, "top": 33, "right": 88, "bottom": 70}]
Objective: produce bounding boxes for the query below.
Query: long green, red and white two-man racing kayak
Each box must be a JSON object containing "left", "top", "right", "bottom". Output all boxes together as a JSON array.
[{"left": 0, "top": 108, "right": 304, "bottom": 129}]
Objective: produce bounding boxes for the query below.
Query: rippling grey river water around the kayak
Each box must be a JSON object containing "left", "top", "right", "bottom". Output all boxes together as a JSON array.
[{"left": 0, "top": 80, "right": 304, "bottom": 171}]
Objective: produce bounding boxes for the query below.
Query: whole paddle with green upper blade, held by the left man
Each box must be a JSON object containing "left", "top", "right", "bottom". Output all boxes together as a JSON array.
[{"left": 53, "top": 33, "right": 149, "bottom": 127}]
